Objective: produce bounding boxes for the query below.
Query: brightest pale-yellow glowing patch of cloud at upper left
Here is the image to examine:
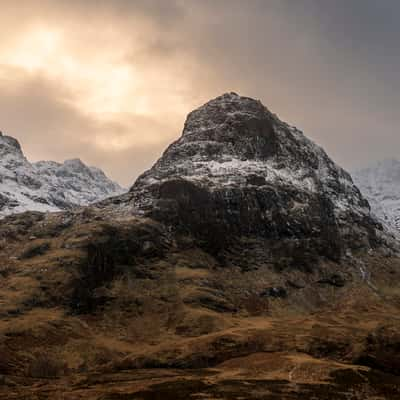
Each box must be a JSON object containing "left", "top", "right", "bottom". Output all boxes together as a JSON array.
[{"left": 1, "top": 26, "right": 148, "bottom": 117}]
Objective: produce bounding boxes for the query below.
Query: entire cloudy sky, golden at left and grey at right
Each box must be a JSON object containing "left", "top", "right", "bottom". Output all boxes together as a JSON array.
[{"left": 0, "top": 0, "right": 400, "bottom": 187}]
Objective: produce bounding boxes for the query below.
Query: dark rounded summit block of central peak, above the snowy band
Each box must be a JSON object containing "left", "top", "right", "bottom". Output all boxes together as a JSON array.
[{"left": 182, "top": 93, "right": 277, "bottom": 160}]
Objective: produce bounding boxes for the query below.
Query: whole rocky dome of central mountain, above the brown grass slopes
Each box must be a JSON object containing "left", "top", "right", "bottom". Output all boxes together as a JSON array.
[{"left": 126, "top": 93, "right": 382, "bottom": 260}]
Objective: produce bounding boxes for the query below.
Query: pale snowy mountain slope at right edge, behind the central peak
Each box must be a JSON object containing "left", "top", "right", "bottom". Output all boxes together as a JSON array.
[{"left": 353, "top": 159, "right": 400, "bottom": 230}]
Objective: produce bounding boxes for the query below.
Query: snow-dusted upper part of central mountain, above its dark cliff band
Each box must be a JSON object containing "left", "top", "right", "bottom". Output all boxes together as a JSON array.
[{"left": 131, "top": 93, "right": 368, "bottom": 215}]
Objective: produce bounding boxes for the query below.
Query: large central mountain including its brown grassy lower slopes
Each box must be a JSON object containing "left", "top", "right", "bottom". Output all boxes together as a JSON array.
[{"left": 0, "top": 93, "right": 400, "bottom": 400}]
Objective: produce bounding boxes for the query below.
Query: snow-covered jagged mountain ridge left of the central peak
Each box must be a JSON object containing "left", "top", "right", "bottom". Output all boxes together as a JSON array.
[{"left": 0, "top": 133, "right": 124, "bottom": 217}]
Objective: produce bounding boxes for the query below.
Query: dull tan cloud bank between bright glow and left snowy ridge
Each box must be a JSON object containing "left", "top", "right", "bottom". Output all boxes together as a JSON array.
[{"left": 0, "top": 68, "right": 177, "bottom": 186}]
